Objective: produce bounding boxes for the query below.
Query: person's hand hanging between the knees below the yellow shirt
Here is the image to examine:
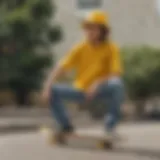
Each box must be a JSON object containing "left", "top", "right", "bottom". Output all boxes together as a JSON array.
[{"left": 86, "top": 82, "right": 99, "bottom": 100}]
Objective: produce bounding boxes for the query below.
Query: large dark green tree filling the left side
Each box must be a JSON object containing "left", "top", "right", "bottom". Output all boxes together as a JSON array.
[{"left": 0, "top": 0, "right": 61, "bottom": 104}]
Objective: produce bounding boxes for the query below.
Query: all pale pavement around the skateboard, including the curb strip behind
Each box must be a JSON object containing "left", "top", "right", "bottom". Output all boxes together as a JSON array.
[{"left": 0, "top": 108, "right": 160, "bottom": 160}]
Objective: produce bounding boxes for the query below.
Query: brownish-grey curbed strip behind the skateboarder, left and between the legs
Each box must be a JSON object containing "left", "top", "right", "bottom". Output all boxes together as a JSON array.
[{"left": 0, "top": 110, "right": 101, "bottom": 134}]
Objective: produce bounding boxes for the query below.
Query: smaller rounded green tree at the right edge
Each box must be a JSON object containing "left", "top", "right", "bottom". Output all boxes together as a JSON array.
[{"left": 122, "top": 46, "right": 160, "bottom": 117}]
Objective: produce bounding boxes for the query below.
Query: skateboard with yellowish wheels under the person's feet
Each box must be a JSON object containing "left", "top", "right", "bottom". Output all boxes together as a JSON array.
[{"left": 49, "top": 132, "right": 114, "bottom": 150}]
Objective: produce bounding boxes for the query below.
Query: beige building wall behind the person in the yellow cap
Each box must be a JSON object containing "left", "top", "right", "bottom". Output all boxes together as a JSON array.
[{"left": 55, "top": 0, "right": 160, "bottom": 59}]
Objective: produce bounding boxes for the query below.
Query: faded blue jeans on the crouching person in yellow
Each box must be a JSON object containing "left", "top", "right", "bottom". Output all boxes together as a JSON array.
[{"left": 51, "top": 78, "right": 124, "bottom": 131}]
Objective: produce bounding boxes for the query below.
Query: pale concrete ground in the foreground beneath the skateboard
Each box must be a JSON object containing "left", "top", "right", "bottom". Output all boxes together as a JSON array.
[{"left": 0, "top": 123, "right": 160, "bottom": 160}]
